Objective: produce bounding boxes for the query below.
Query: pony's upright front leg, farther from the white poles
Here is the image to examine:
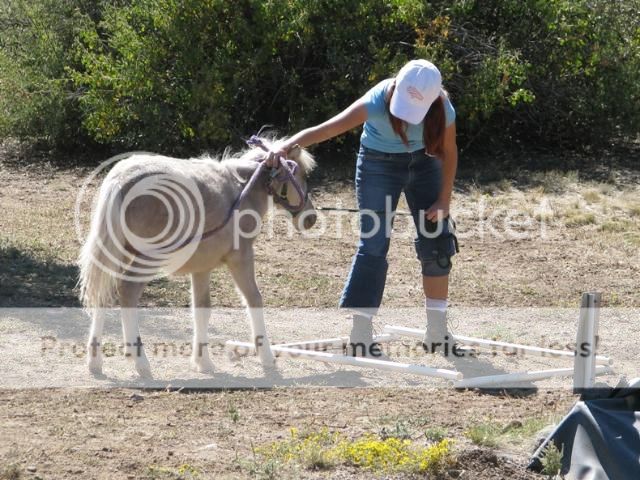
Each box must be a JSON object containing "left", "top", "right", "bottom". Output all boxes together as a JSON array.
[{"left": 191, "top": 272, "right": 214, "bottom": 373}]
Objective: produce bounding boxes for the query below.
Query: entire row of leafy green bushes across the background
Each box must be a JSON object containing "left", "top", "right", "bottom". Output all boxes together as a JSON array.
[{"left": 0, "top": 0, "right": 640, "bottom": 153}]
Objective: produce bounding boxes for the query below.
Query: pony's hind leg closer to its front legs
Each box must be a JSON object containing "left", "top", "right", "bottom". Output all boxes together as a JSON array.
[{"left": 118, "top": 280, "right": 152, "bottom": 378}]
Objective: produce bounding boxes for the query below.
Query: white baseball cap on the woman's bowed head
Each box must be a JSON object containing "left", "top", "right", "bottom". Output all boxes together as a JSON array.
[{"left": 389, "top": 60, "right": 442, "bottom": 125}]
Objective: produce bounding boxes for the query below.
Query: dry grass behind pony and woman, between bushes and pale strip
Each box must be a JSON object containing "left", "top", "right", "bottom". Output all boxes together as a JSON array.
[{"left": 0, "top": 161, "right": 640, "bottom": 307}]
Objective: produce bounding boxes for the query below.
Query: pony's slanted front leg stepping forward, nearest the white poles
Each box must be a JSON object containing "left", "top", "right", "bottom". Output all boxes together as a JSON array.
[{"left": 226, "top": 246, "right": 275, "bottom": 368}]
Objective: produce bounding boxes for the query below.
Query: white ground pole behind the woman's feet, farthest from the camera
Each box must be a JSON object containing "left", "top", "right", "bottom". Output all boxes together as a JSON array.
[{"left": 384, "top": 325, "right": 613, "bottom": 365}]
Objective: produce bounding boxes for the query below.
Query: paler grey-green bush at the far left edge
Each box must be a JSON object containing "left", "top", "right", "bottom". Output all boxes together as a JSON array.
[{"left": 0, "top": 0, "right": 98, "bottom": 147}]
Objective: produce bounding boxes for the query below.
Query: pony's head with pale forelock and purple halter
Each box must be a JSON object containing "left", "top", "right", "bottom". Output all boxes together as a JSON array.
[{"left": 269, "top": 145, "right": 317, "bottom": 231}]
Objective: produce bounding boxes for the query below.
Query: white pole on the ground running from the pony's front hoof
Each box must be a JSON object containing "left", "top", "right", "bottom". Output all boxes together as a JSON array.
[{"left": 227, "top": 341, "right": 462, "bottom": 380}]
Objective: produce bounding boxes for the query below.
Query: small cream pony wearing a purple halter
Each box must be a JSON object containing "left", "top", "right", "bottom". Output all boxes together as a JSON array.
[{"left": 78, "top": 137, "right": 316, "bottom": 378}]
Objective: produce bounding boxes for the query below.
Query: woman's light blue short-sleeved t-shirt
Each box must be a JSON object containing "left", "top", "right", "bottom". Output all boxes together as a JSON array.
[{"left": 360, "top": 78, "right": 456, "bottom": 153}]
